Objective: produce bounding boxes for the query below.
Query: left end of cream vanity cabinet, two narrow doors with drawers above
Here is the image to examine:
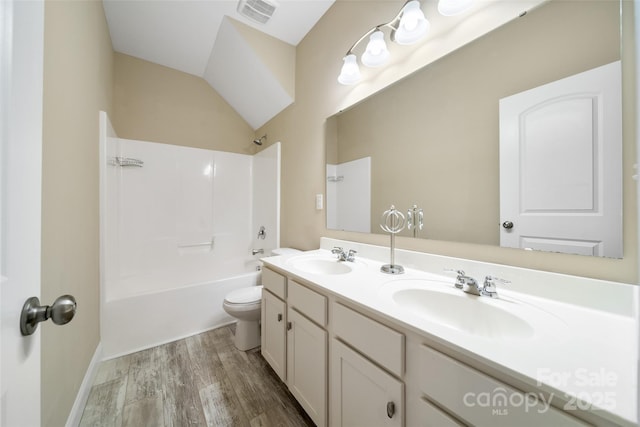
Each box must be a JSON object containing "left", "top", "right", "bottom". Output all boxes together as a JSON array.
[{"left": 261, "top": 268, "right": 328, "bottom": 426}]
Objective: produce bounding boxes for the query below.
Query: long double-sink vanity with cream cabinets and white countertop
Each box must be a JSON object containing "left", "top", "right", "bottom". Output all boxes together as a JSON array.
[{"left": 261, "top": 238, "right": 638, "bottom": 427}]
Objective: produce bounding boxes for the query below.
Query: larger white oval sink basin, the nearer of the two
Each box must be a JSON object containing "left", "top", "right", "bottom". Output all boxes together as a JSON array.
[{"left": 380, "top": 280, "right": 561, "bottom": 339}]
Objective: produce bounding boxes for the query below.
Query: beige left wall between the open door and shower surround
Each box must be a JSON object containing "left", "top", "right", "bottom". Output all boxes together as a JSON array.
[{"left": 41, "top": 0, "right": 113, "bottom": 426}]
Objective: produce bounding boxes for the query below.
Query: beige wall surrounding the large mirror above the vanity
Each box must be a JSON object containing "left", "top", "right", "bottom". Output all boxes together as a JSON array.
[{"left": 258, "top": 0, "right": 638, "bottom": 283}]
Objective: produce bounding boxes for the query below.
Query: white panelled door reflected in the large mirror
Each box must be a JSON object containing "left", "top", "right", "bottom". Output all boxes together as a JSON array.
[{"left": 500, "top": 61, "right": 622, "bottom": 258}]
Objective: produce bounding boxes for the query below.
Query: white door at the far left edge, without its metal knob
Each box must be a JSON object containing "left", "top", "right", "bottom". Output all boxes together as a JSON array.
[{"left": 0, "top": 0, "right": 44, "bottom": 427}]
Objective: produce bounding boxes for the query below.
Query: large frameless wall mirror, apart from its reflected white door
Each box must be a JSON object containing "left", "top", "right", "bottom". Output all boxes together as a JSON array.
[{"left": 326, "top": 0, "right": 622, "bottom": 258}]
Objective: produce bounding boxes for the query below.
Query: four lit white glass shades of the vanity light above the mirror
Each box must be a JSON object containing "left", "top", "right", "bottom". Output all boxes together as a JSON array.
[{"left": 338, "top": 0, "right": 473, "bottom": 85}]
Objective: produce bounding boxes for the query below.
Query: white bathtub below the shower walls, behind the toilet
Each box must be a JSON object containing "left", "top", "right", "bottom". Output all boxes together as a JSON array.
[{"left": 101, "top": 267, "right": 260, "bottom": 359}]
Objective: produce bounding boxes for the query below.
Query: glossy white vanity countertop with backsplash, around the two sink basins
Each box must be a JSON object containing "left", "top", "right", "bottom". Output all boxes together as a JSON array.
[{"left": 262, "top": 238, "right": 638, "bottom": 425}]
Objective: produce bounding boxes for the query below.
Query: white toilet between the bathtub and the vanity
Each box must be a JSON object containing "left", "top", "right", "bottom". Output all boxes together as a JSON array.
[{"left": 222, "top": 248, "right": 300, "bottom": 351}]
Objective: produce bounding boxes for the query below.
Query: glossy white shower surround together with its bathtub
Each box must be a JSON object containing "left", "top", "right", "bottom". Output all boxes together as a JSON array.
[{"left": 100, "top": 113, "right": 280, "bottom": 358}]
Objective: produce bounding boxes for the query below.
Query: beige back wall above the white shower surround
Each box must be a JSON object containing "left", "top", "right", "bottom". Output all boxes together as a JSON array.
[{"left": 111, "top": 53, "right": 256, "bottom": 154}]
